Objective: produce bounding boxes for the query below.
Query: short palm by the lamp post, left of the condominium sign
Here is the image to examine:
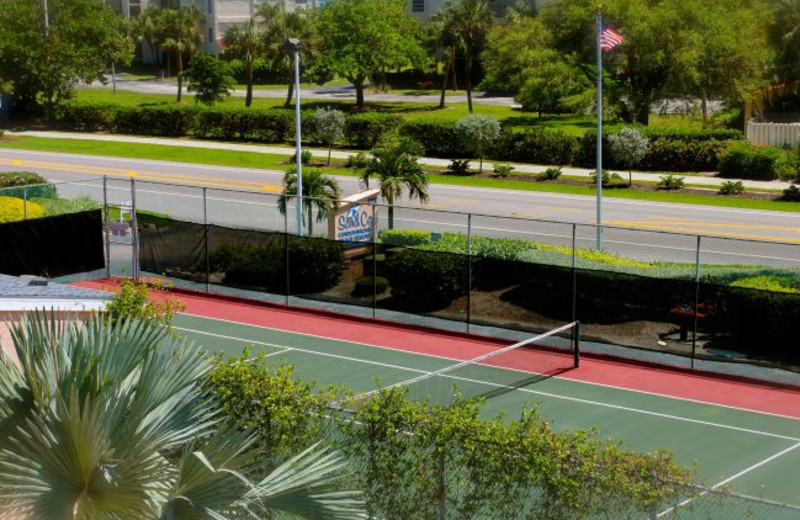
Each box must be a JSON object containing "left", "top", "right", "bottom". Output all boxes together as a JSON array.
[{"left": 278, "top": 168, "right": 342, "bottom": 236}]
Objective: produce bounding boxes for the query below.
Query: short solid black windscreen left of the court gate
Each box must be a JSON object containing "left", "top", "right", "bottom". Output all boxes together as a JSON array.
[{"left": 0, "top": 209, "right": 105, "bottom": 277}]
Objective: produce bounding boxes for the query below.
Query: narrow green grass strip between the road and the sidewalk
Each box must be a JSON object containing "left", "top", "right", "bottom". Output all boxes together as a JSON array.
[{"left": 0, "top": 137, "right": 800, "bottom": 213}]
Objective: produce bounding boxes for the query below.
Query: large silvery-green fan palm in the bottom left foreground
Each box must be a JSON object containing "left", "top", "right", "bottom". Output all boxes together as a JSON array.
[{"left": 0, "top": 314, "right": 361, "bottom": 520}]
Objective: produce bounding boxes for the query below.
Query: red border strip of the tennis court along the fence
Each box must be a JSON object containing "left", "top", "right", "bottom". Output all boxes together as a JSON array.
[{"left": 74, "top": 281, "right": 800, "bottom": 419}]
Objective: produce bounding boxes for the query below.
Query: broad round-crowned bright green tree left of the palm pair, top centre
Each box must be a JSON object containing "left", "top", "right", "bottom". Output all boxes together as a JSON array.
[{"left": 315, "top": 0, "right": 425, "bottom": 108}]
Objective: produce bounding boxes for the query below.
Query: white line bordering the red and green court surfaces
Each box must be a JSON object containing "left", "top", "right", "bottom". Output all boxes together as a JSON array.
[{"left": 180, "top": 312, "right": 800, "bottom": 424}]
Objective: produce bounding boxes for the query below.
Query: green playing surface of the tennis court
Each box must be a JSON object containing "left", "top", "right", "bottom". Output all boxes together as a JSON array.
[{"left": 174, "top": 314, "right": 800, "bottom": 520}]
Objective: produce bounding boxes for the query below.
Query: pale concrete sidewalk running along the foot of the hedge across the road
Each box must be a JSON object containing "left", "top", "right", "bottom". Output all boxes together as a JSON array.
[{"left": 7, "top": 131, "right": 791, "bottom": 190}]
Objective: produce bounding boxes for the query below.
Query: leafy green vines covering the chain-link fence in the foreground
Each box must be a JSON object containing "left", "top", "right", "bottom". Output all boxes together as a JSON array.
[{"left": 209, "top": 353, "right": 689, "bottom": 519}]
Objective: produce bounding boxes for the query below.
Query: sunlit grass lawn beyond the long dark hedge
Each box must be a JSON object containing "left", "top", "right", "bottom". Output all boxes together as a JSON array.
[{"left": 73, "top": 89, "right": 702, "bottom": 136}]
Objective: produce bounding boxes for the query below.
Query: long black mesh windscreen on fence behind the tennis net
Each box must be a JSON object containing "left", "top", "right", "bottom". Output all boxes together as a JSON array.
[{"left": 140, "top": 219, "right": 800, "bottom": 371}]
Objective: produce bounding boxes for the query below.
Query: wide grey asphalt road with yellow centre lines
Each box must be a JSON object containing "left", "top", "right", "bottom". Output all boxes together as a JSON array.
[{"left": 0, "top": 149, "right": 800, "bottom": 268}]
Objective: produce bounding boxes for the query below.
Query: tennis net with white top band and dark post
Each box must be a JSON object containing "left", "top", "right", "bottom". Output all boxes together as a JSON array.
[{"left": 356, "top": 322, "right": 580, "bottom": 406}]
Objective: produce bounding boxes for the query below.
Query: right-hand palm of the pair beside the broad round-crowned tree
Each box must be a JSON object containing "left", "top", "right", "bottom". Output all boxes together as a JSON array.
[{"left": 451, "top": 0, "right": 494, "bottom": 114}]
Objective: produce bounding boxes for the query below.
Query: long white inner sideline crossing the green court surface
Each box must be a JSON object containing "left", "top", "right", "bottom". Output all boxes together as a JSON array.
[{"left": 173, "top": 327, "right": 800, "bottom": 443}]
